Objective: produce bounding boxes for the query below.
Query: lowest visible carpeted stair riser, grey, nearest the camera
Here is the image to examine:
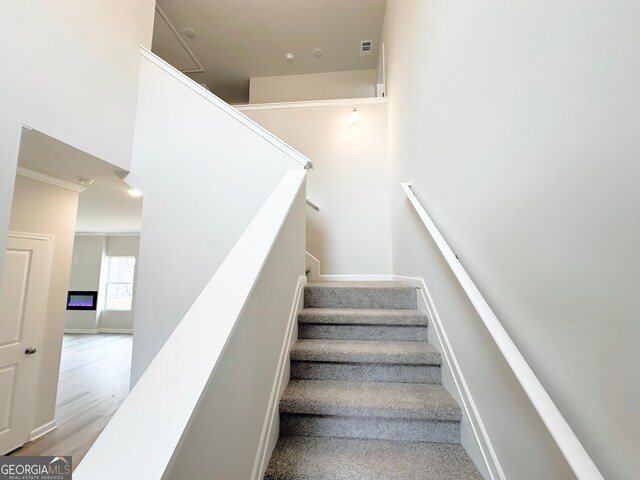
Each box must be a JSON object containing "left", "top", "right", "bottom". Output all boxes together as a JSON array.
[{"left": 280, "top": 414, "right": 460, "bottom": 443}]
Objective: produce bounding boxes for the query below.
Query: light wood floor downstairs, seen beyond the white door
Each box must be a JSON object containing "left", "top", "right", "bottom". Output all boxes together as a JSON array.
[{"left": 11, "top": 334, "right": 132, "bottom": 469}]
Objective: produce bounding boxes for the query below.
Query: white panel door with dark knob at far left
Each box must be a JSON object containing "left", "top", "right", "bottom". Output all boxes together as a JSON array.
[{"left": 0, "top": 233, "right": 53, "bottom": 454}]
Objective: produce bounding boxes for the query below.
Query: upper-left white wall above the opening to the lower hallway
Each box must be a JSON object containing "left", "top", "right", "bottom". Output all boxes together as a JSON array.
[{"left": 0, "top": 0, "right": 155, "bottom": 276}]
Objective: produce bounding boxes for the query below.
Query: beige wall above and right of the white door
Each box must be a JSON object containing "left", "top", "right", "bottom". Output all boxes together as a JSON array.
[{"left": 10, "top": 176, "right": 78, "bottom": 429}]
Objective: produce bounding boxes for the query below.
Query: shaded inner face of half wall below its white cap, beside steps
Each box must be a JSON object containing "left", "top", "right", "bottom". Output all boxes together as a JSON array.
[{"left": 167, "top": 181, "right": 305, "bottom": 480}]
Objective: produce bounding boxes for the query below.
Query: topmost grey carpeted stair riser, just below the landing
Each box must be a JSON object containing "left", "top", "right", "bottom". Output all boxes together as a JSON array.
[{"left": 304, "top": 287, "right": 418, "bottom": 310}]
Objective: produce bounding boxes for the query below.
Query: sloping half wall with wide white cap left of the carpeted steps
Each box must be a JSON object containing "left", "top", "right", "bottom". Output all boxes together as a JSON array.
[{"left": 74, "top": 169, "right": 306, "bottom": 480}]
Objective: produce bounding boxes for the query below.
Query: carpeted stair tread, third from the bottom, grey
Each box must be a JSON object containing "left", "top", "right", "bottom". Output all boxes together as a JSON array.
[{"left": 291, "top": 339, "right": 441, "bottom": 365}]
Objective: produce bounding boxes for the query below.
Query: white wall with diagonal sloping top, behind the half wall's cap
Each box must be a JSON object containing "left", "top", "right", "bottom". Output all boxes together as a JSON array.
[{"left": 127, "top": 54, "right": 303, "bottom": 383}]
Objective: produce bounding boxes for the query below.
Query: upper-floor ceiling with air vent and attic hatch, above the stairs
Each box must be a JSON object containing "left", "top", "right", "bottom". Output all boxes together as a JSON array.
[{"left": 153, "top": 0, "right": 386, "bottom": 103}]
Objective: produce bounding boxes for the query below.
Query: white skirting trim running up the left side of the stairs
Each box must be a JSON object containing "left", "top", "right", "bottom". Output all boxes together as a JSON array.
[{"left": 251, "top": 276, "right": 307, "bottom": 480}]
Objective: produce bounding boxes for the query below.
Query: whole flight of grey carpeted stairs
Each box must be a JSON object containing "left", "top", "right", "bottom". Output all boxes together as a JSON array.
[{"left": 264, "top": 282, "right": 482, "bottom": 480}]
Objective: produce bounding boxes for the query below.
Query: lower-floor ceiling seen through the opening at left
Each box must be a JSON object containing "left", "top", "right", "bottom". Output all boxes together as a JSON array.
[{"left": 18, "top": 128, "right": 142, "bottom": 233}]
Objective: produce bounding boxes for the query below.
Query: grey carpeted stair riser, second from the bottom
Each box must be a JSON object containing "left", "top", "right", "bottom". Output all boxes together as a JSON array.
[{"left": 291, "top": 361, "right": 441, "bottom": 384}]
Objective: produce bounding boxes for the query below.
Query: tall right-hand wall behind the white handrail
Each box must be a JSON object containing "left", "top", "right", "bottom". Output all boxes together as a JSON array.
[{"left": 383, "top": 0, "right": 640, "bottom": 479}]
